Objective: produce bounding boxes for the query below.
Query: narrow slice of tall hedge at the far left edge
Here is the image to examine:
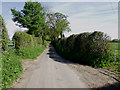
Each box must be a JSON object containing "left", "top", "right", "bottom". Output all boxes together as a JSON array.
[{"left": 0, "top": 15, "right": 9, "bottom": 51}]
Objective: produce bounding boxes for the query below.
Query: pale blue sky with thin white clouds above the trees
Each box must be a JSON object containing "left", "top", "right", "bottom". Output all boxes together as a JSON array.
[{"left": 0, "top": 0, "right": 118, "bottom": 39}]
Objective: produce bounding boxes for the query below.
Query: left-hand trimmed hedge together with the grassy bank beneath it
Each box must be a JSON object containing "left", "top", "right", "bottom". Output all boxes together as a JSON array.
[{"left": 13, "top": 31, "right": 46, "bottom": 59}]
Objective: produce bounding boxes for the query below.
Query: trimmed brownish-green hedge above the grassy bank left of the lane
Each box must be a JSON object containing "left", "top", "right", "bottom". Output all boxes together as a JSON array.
[{"left": 13, "top": 31, "right": 42, "bottom": 49}]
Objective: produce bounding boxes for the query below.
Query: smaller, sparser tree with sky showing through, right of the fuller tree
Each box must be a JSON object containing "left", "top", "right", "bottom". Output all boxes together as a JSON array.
[{"left": 47, "top": 12, "right": 71, "bottom": 40}]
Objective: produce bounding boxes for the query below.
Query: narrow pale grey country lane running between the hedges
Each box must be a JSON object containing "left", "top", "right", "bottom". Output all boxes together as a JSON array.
[{"left": 13, "top": 45, "right": 87, "bottom": 88}]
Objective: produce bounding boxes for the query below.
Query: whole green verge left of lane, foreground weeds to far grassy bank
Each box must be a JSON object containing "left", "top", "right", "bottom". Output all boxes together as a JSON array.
[{"left": 1, "top": 45, "right": 46, "bottom": 88}]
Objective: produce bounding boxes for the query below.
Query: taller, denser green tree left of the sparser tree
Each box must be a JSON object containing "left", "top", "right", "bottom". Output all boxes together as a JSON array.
[{"left": 11, "top": 1, "right": 45, "bottom": 36}]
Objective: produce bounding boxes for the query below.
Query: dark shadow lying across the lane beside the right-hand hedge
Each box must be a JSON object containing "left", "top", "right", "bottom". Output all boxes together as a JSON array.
[{"left": 47, "top": 44, "right": 76, "bottom": 64}]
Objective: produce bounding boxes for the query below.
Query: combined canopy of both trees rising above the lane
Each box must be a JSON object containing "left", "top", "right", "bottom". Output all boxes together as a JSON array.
[{"left": 11, "top": 1, "right": 71, "bottom": 43}]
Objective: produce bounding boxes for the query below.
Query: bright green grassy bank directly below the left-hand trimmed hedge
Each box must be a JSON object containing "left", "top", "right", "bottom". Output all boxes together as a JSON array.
[{"left": 16, "top": 45, "right": 45, "bottom": 59}]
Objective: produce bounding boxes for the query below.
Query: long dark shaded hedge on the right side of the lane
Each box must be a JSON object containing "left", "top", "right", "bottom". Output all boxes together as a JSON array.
[{"left": 52, "top": 31, "right": 114, "bottom": 67}]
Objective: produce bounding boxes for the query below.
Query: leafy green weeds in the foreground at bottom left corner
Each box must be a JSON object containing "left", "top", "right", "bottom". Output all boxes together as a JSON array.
[{"left": 2, "top": 49, "right": 22, "bottom": 88}]
